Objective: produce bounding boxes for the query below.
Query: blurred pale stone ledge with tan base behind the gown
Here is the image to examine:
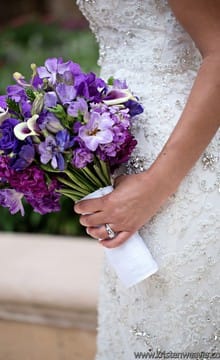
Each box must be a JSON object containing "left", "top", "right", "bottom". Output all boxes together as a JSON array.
[{"left": 0, "top": 233, "right": 103, "bottom": 360}]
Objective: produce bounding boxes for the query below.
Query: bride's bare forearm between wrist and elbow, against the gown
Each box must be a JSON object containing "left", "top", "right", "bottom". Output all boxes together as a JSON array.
[{"left": 148, "top": 54, "right": 220, "bottom": 197}]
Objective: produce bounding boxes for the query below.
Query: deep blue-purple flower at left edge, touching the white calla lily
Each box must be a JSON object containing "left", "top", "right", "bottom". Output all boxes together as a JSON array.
[{"left": 0, "top": 118, "right": 19, "bottom": 154}]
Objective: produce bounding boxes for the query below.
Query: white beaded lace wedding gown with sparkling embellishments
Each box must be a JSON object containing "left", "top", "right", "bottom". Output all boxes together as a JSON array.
[{"left": 78, "top": 0, "right": 220, "bottom": 360}]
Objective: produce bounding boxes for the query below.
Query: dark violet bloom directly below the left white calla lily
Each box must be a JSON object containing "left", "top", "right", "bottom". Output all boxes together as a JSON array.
[{"left": 10, "top": 142, "right": 35, "bottom": 171}]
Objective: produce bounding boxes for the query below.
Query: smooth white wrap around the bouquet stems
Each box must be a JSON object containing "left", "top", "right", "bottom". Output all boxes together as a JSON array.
[{"left": 81, "top": 186, "right": 158, "bottom": 288}]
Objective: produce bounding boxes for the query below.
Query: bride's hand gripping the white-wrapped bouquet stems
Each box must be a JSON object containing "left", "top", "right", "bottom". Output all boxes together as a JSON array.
[{"left": 75, "top": 171, "right": 170, "bottom": 248}]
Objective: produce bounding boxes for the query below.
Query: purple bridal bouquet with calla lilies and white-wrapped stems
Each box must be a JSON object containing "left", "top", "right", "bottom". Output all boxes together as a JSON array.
[{"left": 0, "top": 58, "right": 157, "bottom": 286}]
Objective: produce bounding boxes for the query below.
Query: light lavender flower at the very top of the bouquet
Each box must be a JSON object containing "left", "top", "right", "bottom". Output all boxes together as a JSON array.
[{"left": 37, "top": 58, "right": 81, "bottom": 85}]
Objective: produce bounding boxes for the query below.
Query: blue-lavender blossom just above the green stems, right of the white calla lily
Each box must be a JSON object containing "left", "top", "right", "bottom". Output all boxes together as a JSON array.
[{"left": 38, "top": 130, "right": 74, "bottom": 171}]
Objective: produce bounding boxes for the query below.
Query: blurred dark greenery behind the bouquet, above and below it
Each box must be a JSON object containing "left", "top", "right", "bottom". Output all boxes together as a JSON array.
[{"left": 0, "top": 0, "right": 99, "bottom": 235}]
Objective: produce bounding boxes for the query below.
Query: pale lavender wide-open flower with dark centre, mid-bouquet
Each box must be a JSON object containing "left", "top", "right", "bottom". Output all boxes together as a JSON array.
[{"left": 79, "top": 112, "right": 114, "bottom": 151}]
